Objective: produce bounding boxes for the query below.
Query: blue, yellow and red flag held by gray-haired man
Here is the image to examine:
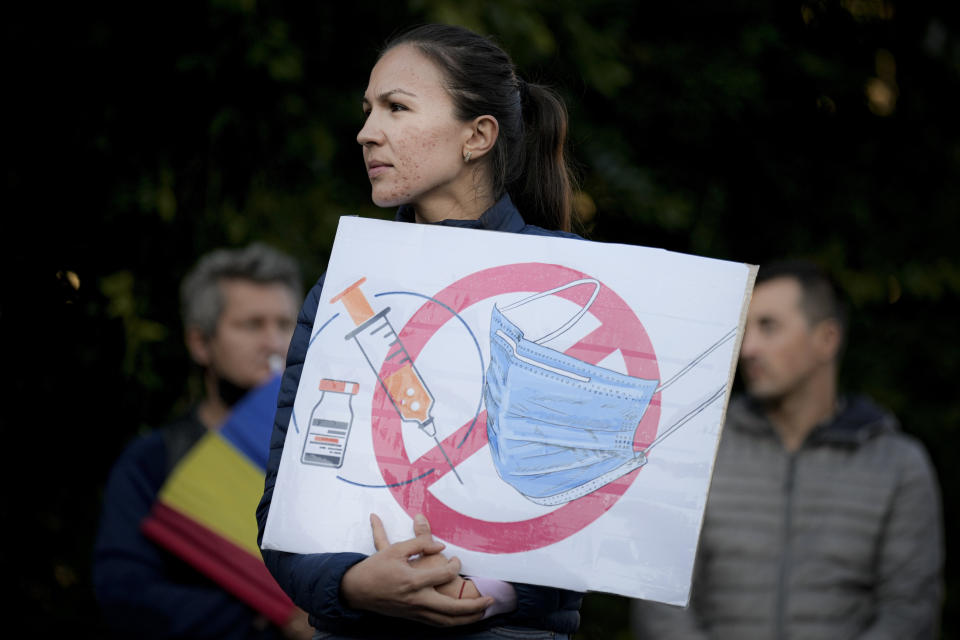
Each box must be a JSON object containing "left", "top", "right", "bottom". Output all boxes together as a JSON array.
[{"left": 142, "top": 376, "right": 294, "bottom": 626}]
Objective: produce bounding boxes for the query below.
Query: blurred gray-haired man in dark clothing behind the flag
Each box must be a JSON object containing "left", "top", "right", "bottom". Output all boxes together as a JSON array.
[{"left": 93, "top": 244, "right": 312, "bottom": 640}]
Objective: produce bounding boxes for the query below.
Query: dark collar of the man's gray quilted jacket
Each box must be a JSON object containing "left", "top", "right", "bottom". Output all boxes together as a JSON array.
[{"left": 728, "top": 396, "right": 899, "bottom": 447}]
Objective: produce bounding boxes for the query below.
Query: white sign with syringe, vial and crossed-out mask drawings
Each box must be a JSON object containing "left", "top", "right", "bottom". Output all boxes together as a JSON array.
[{"left": 263, "top": 217, "right": 756, "bottom": 604}]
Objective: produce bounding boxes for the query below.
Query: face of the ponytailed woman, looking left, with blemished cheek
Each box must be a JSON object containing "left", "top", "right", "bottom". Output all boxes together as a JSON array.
[{"left": 357, "top": 44, "right": 473, "bottom": 221}]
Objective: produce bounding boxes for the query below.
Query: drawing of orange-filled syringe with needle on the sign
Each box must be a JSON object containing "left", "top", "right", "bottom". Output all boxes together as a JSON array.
[{"left": 330, "top": 278, "right": 463, "bottom": 484}]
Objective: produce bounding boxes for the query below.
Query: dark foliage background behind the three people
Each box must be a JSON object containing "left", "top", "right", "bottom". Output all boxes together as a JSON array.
[{"left": 0, "top": 0, "right": 960, "bottom": 639}]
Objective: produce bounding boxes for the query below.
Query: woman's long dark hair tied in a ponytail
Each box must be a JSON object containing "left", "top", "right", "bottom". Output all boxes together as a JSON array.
[{"left": 380, "top": 24, "right": 573, "bottom": 231}]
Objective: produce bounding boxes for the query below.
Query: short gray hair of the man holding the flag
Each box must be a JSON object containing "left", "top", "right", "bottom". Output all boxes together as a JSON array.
[{"left": 180, "top": 242, "right": 303, "bottom": 336}]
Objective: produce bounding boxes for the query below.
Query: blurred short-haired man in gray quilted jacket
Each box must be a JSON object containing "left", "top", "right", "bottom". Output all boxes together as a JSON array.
[{"left": 632, "top": 263, "right": 943, "bottom": 640}]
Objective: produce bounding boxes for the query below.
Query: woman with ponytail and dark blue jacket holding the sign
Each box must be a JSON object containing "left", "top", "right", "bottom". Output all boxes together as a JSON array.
[{"left": 257, "top": 25, "right": 581, "bottom": 639}]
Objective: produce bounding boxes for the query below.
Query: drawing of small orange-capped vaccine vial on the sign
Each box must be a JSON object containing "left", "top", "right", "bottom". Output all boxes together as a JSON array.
[{"left": 300, "top": 378, "right": 360, "bottom": 468}]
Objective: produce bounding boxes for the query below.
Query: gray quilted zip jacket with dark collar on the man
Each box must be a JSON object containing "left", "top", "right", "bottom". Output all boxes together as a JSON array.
[{"left": 633, "top": 398, "right": 943, "bottom": 640}]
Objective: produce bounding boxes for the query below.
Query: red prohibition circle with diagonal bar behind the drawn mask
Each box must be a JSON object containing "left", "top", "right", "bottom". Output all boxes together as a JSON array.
[{"left": 371, "top": 263, "right": 660, "bottom": 553}]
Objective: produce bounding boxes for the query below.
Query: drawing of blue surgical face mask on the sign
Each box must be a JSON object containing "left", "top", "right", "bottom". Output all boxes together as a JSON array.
[{"left": 484, "top": 280, "right": 658, "bottom": 506}]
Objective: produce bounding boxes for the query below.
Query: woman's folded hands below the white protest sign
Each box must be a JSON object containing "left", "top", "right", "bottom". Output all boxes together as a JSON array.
[{"left": 340, "top": 514, "right": 493, "bottom": 627}]
